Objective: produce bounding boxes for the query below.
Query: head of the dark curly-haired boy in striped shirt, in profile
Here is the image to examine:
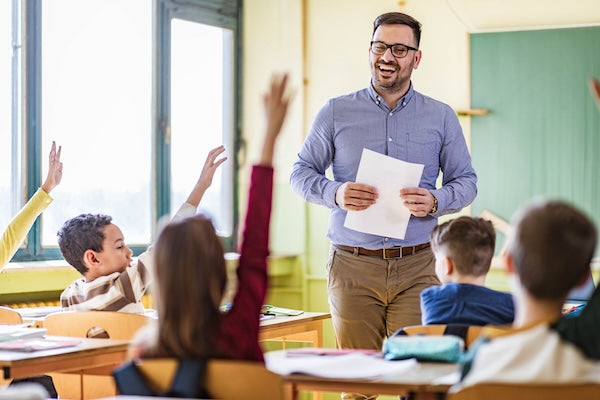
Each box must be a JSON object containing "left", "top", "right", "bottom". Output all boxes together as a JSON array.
[{"left": 58, "top": 214, "right": 132, "bottom": 280}]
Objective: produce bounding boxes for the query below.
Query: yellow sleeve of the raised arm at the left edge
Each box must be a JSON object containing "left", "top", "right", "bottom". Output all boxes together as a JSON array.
[{"left": 0, "top": 188, "right": 52, "bottom": 268}]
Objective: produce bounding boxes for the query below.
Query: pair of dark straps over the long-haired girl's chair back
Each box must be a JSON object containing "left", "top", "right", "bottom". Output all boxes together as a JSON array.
[{"left": 113, "top": 360, "right": 211, "bottom": 399}]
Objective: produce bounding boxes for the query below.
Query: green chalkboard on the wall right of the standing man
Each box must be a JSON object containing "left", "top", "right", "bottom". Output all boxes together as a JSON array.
[{"left": 470, "top": 27, "right": 600, "bottom": 253}]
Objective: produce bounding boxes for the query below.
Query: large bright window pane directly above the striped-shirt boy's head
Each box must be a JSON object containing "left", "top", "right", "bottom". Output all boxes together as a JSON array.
[{"left": 42, "top": 0, "right": 152, "bottom": 246}]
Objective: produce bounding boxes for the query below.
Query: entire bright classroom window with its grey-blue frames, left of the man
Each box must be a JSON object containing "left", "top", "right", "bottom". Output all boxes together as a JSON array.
[{"left": 0, "top": 0, "right": 240, "bottom": 261}]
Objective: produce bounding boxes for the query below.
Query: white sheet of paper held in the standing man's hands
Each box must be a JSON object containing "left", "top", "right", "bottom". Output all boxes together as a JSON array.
[{"left": 344, "top": 149, "right": 424, "bottom": 239}]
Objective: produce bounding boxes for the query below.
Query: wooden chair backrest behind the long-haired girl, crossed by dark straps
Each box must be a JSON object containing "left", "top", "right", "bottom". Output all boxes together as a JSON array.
[{"left": 138, "top": 358, "right": 283, "bottom": 400}]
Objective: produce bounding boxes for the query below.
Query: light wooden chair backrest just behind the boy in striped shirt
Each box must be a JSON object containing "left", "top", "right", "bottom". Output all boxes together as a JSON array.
[{"left": 44, "top": 311, "right": 151, "bottom": 340}]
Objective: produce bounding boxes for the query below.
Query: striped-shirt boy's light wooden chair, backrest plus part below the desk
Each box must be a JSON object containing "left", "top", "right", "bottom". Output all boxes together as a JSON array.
[{"left": 43, "top": 311, "right": 151, "bottom": 399}]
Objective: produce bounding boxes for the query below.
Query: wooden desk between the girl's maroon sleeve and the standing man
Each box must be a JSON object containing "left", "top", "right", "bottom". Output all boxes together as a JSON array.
[{"left": 259, "top": 312, "right": 331, "bottom": 349}]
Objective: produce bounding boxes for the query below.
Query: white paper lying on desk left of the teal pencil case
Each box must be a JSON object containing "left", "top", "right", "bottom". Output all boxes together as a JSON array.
[{"left": 265, "top": 353, "right": 417, "bottom": 379}]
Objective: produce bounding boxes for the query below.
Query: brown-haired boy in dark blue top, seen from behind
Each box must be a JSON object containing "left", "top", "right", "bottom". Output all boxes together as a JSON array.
[{"left": 421, "top": 216, "right": 515, "bottom": 325}]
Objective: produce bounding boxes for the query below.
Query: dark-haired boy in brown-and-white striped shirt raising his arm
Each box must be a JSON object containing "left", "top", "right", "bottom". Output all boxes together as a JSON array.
[{"left": 58, "top": 146, "right": 227, "bottom": 314}]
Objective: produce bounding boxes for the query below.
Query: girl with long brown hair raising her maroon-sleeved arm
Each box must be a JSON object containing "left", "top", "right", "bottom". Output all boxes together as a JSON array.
[{"left": 132, "top": 75, "right": 290, "bottom": 361}]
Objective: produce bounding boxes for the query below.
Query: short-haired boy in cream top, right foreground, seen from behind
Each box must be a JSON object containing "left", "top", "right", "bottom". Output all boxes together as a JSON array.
[{"left": 454, "top": 201, "right": 600, "bottom": 386}]
